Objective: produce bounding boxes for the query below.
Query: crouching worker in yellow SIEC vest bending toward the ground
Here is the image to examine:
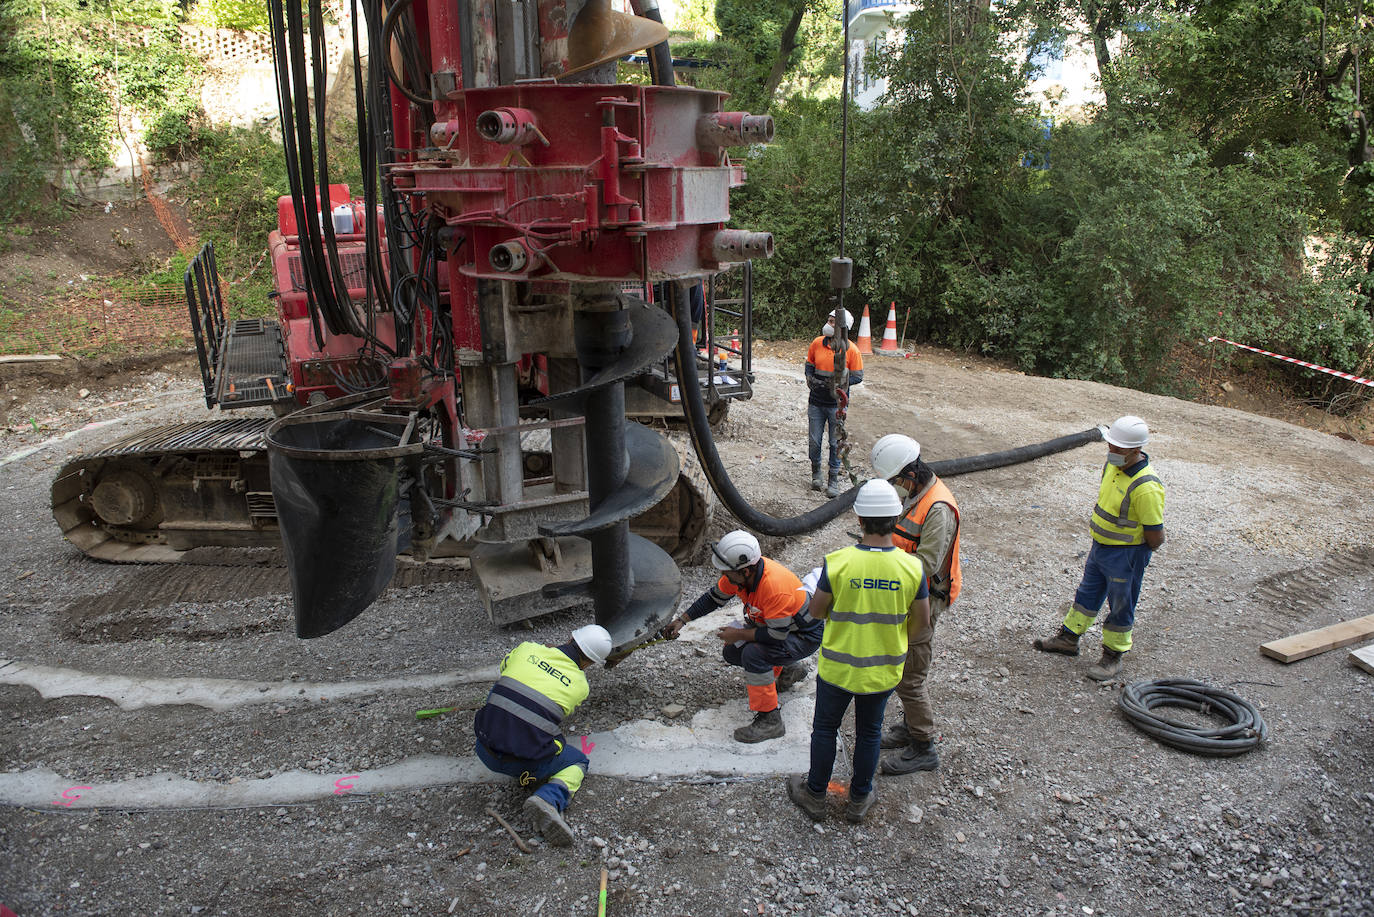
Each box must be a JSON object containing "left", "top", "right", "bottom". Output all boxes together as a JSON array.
[{"left": 473, "top": 624, "right": 611, "bottom": 847}]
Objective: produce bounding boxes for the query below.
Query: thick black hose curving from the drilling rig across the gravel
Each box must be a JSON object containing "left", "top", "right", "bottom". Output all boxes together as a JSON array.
[{"left": 672, "top": 282, "right": 1102, "bottom": 538}]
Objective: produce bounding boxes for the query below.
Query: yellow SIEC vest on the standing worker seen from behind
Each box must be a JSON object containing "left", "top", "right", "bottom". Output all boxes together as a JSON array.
[{"left": 816, "top": 547, "right": 925, "bottom": 694}]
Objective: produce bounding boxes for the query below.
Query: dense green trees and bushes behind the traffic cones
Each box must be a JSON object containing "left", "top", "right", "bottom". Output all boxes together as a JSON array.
[{"left": 738, "top": 0, "right": 1374, "bottom": 401}]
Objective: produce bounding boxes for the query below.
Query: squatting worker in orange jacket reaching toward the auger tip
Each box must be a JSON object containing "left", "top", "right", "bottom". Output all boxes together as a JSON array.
[{"left": 662, "top": 529, "right": 824, "bottom": 742}]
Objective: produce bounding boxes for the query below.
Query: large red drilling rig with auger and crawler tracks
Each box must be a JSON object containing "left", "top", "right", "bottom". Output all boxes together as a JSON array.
[{"left": 52, "top": 0, "right": 780, "bottom": 650}]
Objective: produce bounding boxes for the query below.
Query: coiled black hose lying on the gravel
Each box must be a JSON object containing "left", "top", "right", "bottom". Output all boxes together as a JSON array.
[{"left": 1117, "top": 678, "right": 1270, "bottom": 758}]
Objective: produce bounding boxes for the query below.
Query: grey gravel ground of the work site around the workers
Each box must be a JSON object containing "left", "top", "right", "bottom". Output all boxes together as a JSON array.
[{"left": 0, "top": 346, "right": 1374, "bottom": 917}]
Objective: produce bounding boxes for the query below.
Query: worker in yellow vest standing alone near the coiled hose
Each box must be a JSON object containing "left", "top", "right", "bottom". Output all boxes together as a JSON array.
[{"left": 1035, "top": 415, "right": 1164, "bottom": 682}]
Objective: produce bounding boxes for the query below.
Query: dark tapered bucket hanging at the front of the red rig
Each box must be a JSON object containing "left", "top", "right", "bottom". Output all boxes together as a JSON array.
[{"left": 267, "top": 411, "right": 422, "bottom": 638}]
